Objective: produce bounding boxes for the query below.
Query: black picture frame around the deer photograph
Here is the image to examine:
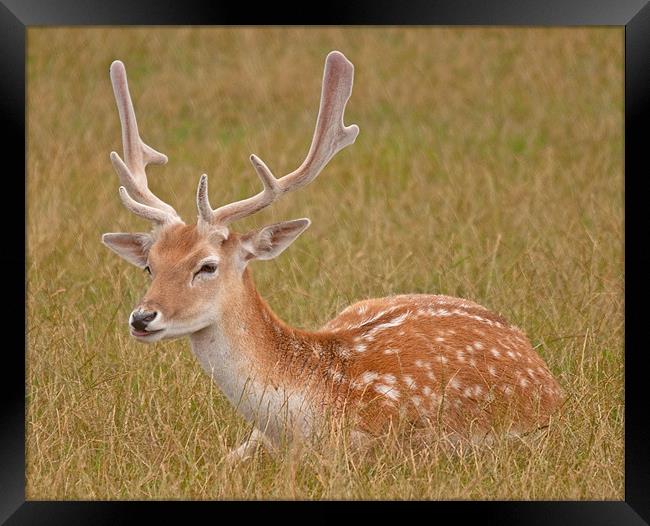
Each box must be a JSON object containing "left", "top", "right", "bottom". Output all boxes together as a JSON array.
[{"left": 6, "top": 0, "right": 650, "bottom": 525}]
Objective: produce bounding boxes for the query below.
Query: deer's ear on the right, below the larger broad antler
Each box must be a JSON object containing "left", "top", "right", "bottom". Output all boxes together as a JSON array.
[{"left": 240, "top": 218, "right": 311, "bottom": 266}]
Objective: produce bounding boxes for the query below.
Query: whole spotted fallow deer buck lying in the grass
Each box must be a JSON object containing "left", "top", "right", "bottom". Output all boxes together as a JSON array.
[{"left": 102, "top": 51, "right": 563, "bottom": 459}]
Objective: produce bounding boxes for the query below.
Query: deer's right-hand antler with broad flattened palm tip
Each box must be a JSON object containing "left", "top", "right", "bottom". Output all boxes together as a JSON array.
[{"left": 197, "top": 51, "right": 359, "bottom": 226}]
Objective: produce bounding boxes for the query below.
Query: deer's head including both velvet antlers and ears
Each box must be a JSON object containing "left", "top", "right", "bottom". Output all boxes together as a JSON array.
[{"left": 102, "top": 51, "right": 359, "bottom": 342}]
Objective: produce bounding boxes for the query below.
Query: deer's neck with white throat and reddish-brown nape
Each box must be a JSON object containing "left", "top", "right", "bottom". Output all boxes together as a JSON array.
[{"left": 190, "top": 270, "right": 315, "bottom": 438}]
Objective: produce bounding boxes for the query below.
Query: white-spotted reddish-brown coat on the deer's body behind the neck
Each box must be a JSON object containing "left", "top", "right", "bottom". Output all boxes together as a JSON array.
[{"left": 306, "top": 295, "right": 562, "bottom": 435}]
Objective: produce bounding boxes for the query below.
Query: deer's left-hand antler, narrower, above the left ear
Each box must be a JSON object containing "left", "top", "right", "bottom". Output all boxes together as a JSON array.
[{"left": 110, "top": 60, "right": 180, "bottom": 223}]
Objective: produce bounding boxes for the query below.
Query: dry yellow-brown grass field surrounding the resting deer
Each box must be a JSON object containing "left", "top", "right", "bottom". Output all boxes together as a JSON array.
[{"left": 26, "top": 28, "right": 624, "bottom": 500}]
